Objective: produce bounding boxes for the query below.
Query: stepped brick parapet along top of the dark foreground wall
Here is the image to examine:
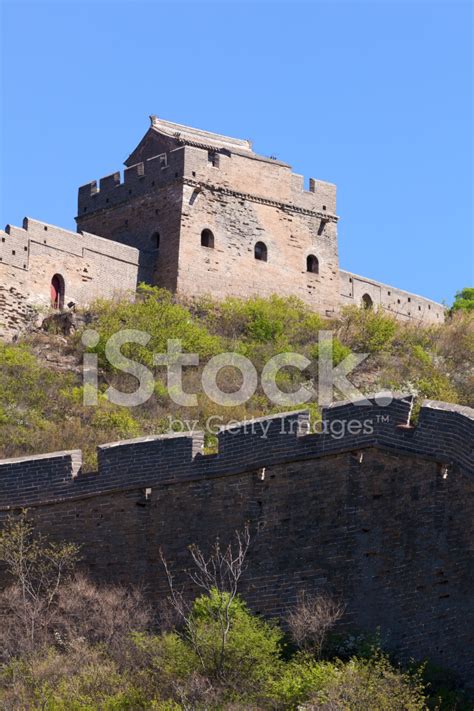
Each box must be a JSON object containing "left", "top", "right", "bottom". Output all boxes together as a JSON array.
[{"left": 0, "top": 394, "right": 474, "bottom": 509}]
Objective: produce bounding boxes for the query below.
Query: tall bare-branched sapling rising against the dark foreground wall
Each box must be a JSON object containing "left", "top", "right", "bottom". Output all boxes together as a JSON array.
[{"left": 160, "top": 524, "right": 250, "bottom": 676}]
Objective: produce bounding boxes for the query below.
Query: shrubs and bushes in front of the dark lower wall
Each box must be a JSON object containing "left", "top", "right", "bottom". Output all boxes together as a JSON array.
[{"left": 0, "top": 514, "right": 471, "bottom": 711}]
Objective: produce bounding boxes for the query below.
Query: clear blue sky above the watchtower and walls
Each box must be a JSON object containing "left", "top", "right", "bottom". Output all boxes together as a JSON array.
[{"left": 0, "top": 0, "right": 474, "bottom": 302}]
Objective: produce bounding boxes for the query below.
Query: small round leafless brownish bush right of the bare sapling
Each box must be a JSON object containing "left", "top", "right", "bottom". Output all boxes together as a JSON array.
[{"left": 287, "top": 592, "right": 345, "bottom": 657}]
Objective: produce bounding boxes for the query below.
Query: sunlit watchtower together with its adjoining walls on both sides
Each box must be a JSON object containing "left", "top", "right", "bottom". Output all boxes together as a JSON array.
[{"left": 0, "top": 116, "right": 444, "bottom": 337}]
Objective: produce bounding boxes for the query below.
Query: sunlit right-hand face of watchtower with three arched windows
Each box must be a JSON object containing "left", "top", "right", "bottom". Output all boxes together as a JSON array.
[{"left": 178, "top": 147, "right": 339, "bottom": 315}]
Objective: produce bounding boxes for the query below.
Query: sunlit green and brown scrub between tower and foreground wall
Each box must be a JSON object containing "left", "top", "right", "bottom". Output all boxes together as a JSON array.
[{"left": 0, "top": 287, "right": 474, "bottom": 467}]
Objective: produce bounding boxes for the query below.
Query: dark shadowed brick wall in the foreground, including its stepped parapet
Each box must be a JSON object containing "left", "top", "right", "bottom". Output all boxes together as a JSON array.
[{"left": 0, "top": 396, "right": 474, "bottom": 681}]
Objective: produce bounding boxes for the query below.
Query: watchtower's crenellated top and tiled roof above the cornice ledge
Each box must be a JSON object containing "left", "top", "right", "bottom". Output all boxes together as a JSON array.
[{"left": 77, "top": 116, "right": 337, "bottom": 222}]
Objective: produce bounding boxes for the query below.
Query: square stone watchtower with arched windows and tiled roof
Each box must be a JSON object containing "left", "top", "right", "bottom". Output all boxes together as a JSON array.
[{"left": 77, "top": 116, "right": 340, "bottom": 314}]
